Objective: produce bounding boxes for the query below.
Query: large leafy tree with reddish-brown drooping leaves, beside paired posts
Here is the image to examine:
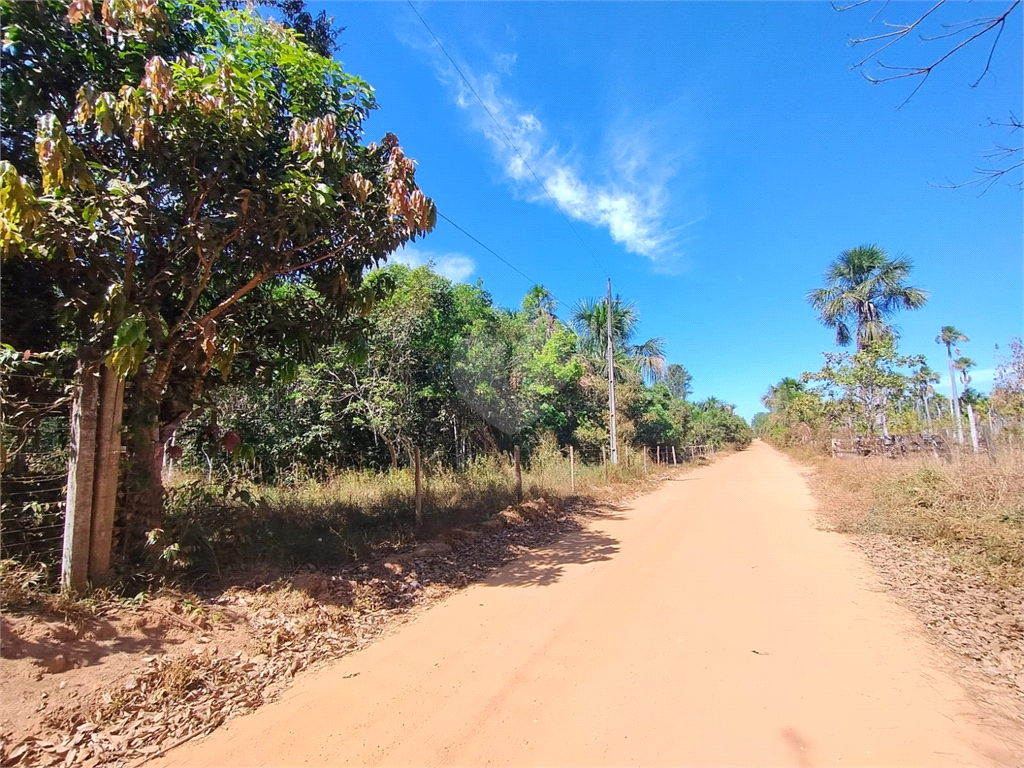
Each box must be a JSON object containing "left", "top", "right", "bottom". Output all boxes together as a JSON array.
[{"left": 0, "top": 0, "right": 434, "bottom": 548}]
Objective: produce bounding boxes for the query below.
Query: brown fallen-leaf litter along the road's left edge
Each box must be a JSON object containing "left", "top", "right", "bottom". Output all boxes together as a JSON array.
[{"left": 0, "top": 499, "right": 594, "bottom": 768}]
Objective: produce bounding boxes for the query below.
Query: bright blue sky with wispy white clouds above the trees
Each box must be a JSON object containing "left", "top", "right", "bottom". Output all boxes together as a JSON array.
[{"left": 310, "top": 2, "right": 1024, "bottom": 418}]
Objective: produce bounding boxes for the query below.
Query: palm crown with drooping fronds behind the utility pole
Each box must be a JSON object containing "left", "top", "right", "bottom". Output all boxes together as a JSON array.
[{"left": 572, "top": 297, "right": 665, "bottom": 382}]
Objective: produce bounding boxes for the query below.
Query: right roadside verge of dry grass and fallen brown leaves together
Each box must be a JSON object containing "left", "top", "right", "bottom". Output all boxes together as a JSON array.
[{"left": 791, "top": 446, "right": 1024, "bottom": 722}]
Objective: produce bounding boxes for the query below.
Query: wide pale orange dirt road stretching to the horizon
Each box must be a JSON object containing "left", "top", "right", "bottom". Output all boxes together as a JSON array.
[{"left": 150, "top": 442, "right": 1024, "bottom": 766}]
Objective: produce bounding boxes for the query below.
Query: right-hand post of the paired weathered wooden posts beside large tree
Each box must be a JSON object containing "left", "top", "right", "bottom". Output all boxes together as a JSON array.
[{"left": 89, "top": 366, "right": 125, "bottom": 585}]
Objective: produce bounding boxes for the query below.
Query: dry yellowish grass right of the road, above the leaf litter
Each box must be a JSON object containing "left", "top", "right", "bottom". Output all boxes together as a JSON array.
[{"left": 795, "top": 449, "right": 1024, "bottom": 588}]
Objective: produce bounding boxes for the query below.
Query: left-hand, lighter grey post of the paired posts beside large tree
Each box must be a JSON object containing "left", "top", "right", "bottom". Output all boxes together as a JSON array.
[{"left": 60, "top": 356, "right": 99, "bottom": 594}]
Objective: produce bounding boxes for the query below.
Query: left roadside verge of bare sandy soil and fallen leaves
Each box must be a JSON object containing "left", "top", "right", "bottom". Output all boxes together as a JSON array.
[{"left": 0, "top": 495, "right": 606, "bottom": 768}]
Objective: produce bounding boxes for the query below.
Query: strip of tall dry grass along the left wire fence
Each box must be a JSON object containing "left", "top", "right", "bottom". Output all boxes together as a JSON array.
[{"left": 157, "top": 447, "right": 664, "bottom": 573}]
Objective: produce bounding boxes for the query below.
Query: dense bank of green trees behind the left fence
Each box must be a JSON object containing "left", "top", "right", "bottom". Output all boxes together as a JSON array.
[{"left": 178, "top": 264, "right": 749, "bottom": 482}]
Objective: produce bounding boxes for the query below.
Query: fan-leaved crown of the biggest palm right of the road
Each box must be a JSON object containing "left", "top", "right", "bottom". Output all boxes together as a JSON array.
[{"left": 807, "top": 246, "right": 928, "bottom": 351}]
